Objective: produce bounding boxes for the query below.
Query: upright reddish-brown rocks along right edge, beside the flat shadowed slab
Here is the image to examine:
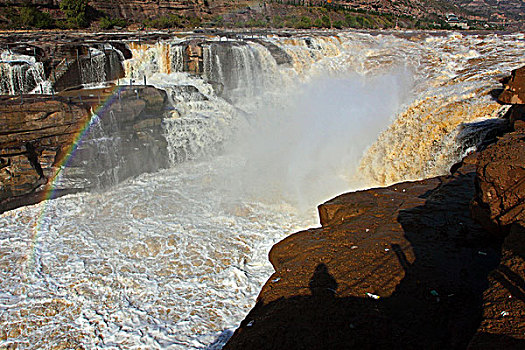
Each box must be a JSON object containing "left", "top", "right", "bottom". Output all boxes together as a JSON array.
[{"left": 470, "top": 67, "right": 525, "bottom": 349}]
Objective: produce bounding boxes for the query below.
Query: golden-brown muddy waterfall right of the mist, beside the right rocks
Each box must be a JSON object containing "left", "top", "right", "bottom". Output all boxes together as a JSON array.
[{"left": 360, "top": 87, "right": 504, "bottom": 186}]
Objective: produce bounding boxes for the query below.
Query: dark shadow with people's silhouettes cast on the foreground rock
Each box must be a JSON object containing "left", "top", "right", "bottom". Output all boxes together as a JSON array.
[{"left": 224, "top": 173, "right": 525, "bottom": 350}]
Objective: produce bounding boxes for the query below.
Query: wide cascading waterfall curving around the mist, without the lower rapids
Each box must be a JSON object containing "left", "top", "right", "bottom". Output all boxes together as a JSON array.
[{"left": 118, "top": 33, "right": 519, "bottom": 193}]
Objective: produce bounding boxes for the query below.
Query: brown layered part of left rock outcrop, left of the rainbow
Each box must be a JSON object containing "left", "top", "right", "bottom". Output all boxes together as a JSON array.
[{"left": 0, "top": 96, "right": 89, "bottom": 202}]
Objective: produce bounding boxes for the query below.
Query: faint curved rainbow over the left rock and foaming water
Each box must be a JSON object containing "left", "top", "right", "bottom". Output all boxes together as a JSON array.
[{"left": 25, "top": 86, "right": 125, "bottom": 277}]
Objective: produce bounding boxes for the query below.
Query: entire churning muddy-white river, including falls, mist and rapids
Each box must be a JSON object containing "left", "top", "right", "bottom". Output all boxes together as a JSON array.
[{"left": 0, "top": 33, "right": 525, "bottom": 349}]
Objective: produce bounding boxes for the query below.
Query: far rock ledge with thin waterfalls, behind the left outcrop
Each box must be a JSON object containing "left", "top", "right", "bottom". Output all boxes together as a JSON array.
[{"left": 0, "top": 33, "right": 292, "bottom": 95}]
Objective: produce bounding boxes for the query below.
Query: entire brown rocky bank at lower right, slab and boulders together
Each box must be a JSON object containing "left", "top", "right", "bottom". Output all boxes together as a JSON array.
[{"left": 225, "top": 69, "right": 525, "bottom": 349}]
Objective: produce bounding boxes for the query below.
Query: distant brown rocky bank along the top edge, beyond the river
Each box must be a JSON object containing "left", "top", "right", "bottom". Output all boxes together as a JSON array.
[{"left": 0, "top": 0, "right": 524, "bottom": 29}]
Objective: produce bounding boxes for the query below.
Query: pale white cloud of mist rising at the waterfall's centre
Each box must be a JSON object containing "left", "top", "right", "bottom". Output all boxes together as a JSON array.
[{"left": 218, "top": 71, "right": 412, "bottom": 210}]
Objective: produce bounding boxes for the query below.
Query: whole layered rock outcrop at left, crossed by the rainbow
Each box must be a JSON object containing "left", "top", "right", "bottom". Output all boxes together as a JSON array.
[{"left": 0, "top": 86, "right": 169, "bottom": 212}]
